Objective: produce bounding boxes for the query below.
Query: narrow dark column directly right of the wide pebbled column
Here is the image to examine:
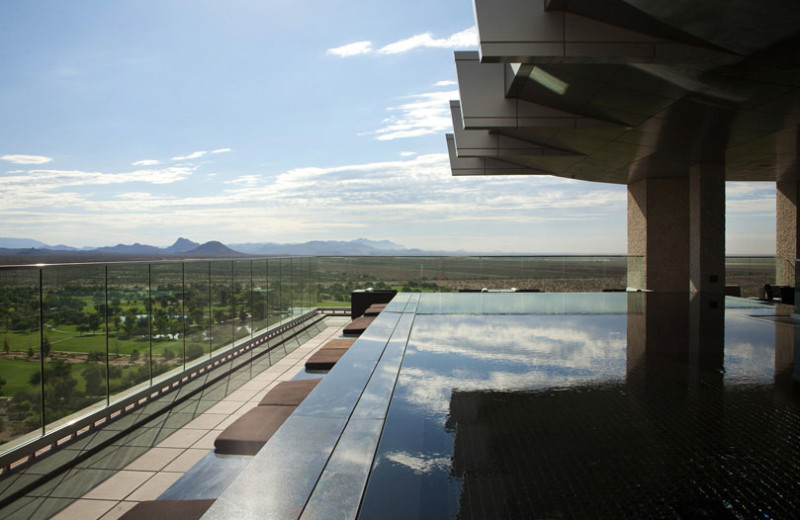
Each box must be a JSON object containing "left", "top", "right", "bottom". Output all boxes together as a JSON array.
[{"left": 689, "top": 161, "right": 725, "bottom": 297}]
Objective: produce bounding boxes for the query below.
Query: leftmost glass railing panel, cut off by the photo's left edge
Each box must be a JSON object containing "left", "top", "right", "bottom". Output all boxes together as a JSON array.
[{"left": 0, "top": 269, "right": 42, "bottom": 449}]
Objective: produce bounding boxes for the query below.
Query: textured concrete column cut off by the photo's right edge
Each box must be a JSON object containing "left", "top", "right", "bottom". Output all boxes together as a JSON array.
[{"left": 775, "top": 127, "right": 800, "bottom": 287}]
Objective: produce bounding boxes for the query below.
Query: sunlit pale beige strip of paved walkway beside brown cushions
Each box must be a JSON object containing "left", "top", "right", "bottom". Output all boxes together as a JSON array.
[{"left": 46, "top": 318, "right": 349, "bottom": 520}]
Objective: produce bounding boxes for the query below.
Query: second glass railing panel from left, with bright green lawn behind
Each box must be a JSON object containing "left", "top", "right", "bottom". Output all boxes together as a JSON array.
[{"left": 41, "top": 265, "right": 107, "bottom": 429}]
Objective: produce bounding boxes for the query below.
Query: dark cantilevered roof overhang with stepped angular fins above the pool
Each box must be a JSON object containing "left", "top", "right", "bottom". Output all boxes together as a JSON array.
[{"left": 446, "top": 0, "right": 800, "bottom": 184}]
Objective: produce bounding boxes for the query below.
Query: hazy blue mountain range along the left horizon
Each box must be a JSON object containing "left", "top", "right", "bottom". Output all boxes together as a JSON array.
[{"left": 0, "top": 237, "right": 450, "bottom": 264}]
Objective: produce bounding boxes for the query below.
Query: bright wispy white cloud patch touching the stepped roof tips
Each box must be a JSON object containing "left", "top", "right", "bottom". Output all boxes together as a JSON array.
[{"left": 375, "top": 90, "right": 458, "bottom": 141}]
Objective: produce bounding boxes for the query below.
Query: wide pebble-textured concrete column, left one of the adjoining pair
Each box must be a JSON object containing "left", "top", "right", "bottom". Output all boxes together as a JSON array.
[{"left": 628, "top": 177, "right": 689, "bottom": 292}]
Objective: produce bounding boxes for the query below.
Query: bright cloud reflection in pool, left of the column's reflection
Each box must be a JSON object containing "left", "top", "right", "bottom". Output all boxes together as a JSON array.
[{"left": 395, "top": 315, "right": 626, "bottom": 414}]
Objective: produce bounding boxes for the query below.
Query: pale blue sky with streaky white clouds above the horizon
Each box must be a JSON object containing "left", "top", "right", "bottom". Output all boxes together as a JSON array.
[{"left": 0, "top": 0, "right": 775, "bottom": 254}]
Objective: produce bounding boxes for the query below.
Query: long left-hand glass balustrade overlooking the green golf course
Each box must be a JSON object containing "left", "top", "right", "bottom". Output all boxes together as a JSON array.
[{"left": 0, "top": 258, "right": 317, "bottom": 452}]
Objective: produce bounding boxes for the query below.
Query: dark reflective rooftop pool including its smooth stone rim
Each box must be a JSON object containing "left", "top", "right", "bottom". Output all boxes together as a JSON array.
[{"left": 202, "top": 293, "right": 800, "bottom": 519}]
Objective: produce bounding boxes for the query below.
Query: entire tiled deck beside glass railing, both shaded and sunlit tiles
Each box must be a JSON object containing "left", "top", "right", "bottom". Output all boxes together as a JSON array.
[{"left": 0, "top": 317, "right": 349, "bottom": 520}]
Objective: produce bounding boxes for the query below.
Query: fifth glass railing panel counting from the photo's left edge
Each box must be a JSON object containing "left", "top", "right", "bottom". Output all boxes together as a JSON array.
[{"left": 184, "top": 262, "right": 212, "bottom": 363}]
